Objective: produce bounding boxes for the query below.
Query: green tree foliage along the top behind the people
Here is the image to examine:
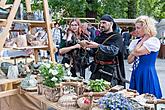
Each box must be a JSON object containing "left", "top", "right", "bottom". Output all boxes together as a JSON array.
[{"left": 7, "top": 0, "right": 165, "bottom": 19}]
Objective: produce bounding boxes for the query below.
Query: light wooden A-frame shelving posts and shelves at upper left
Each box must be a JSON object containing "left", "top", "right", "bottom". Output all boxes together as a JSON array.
[{"left": 0, "top": 0, "right": 55, "bottom": 62}]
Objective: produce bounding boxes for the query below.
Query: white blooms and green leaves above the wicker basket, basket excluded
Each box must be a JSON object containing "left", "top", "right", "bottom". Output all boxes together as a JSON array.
[{"left": 39, "top": 62, "right": 64, "bottom": 88}]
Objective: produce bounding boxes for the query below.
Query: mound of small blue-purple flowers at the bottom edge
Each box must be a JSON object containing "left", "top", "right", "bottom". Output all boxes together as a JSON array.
[{"left": 99, "top": 92, "right": 134, "bottom": 110}]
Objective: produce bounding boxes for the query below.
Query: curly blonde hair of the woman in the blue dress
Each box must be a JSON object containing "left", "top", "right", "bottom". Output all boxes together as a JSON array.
[{"left": 135, "top": 16, "right": 157, "bottom": 37}]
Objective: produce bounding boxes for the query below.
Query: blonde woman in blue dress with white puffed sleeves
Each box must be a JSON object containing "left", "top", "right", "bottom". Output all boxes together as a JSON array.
[{"left": 128, "top": 16, "right": 162, "bottom": 98}]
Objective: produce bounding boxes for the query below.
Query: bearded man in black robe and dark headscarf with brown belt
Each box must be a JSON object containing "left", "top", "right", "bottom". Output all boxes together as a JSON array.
[{"left": 80, "top": 15, "right": 125, "bottom": 86}]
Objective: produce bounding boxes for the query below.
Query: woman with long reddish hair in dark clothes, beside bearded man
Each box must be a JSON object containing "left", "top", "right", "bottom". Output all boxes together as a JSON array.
[{"left": 59, "top": 19, "right": 89, "bottom": 78}]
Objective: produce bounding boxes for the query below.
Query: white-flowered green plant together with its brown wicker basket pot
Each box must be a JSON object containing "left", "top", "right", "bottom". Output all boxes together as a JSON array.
[{"left": 39, "top": 62, "right": 64, "bottom": 102}]
